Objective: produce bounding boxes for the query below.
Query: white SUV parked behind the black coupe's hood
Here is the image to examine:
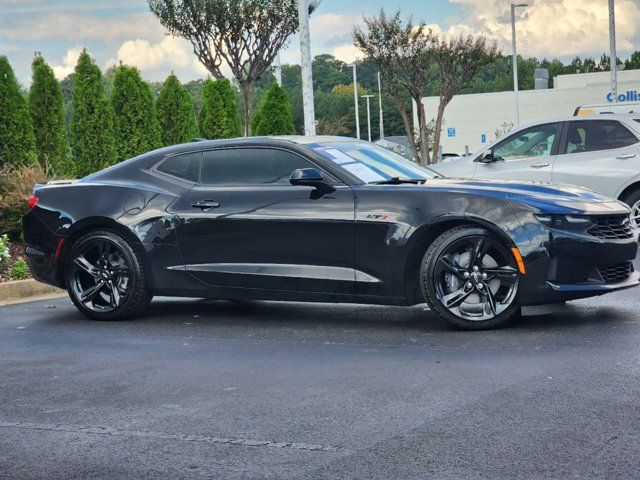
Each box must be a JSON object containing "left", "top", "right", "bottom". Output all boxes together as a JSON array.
[{"left": 431, "top": 115, "right": 640, "bottom": 226}]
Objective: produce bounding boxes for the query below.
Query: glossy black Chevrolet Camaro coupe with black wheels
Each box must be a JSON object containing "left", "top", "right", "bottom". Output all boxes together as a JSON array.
[{"left": 24, "top": 137, "right": 639, "bottom": 329}]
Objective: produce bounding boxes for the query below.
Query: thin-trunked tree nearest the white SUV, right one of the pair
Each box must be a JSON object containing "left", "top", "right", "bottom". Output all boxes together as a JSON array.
[{"left": 432, "top": 35, "right": 500, "bottom": 160}]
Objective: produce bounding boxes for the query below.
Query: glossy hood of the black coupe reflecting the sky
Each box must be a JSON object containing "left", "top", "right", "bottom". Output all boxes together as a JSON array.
[{"left": 425, "top": 178, "right": 629, "bottom": 214}]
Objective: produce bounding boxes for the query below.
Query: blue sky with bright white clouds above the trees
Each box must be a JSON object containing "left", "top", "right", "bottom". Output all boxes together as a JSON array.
[{"left": 0, "top": 0, "right": 640, "bottom": 86}]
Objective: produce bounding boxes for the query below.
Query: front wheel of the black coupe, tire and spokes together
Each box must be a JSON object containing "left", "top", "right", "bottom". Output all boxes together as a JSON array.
[{"left": 420, "top": 226, "right": 521, "bottom": 330}]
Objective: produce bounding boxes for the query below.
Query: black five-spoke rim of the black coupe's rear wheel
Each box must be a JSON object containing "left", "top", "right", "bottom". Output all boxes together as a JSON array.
[{"left": 69, "top": 239, "right": 131, "bottom": 313}]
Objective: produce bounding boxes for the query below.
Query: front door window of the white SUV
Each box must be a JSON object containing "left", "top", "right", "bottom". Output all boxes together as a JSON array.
[{"left": 493, "top": 123, "right": 558, "bottom": 160}]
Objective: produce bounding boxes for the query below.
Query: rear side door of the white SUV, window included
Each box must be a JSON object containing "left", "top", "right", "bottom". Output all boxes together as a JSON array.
[{"left": 552, "top": 120, "right": 640, "bottom": 197}]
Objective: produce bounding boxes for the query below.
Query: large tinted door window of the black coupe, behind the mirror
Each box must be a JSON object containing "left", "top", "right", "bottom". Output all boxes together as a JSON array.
[{"left": 201, "top": 148, "right": 314, "bottom": 187}]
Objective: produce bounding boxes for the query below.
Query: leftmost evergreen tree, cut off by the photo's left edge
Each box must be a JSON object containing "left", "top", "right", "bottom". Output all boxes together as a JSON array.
[{"left": 0, "top": 56, "right": 36, "bottom": 167}]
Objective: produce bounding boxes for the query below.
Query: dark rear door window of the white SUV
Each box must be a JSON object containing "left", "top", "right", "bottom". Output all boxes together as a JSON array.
[{"left": 565, "top": 120, "right": 638, "bottom": 153}]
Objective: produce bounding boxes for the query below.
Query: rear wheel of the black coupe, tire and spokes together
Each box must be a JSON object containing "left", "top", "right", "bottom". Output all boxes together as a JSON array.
[{"left": 65, "top": 230, "right": 152, "bottom": 320}]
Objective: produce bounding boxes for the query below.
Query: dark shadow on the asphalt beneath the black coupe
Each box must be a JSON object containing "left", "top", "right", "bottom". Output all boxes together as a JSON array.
[{"left": 45, "top": 292, "right": 635, "bottom": 337}]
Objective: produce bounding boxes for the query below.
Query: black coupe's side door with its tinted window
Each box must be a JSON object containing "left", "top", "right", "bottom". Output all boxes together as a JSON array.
[{"left": 176, "top": 147, "right": 355, "bottom": 293}]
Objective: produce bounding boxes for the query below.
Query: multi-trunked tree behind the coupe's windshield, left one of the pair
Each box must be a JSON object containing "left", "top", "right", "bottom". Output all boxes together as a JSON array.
[{"left": 353, "top": 10, "right": 437, "bottom": 165}]
